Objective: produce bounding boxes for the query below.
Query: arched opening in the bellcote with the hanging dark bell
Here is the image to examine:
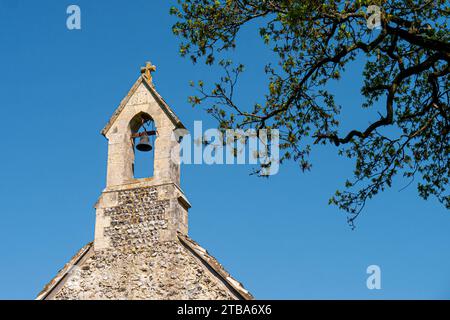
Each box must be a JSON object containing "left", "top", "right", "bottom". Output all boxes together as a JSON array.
[{"left": 130, "top": 112, "right": 156, "bottom": 179}]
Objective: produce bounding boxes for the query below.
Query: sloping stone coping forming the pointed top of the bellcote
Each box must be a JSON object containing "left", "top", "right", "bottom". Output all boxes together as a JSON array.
[{"left": 101, "top": 75, "right": 185, "bottom": 136}]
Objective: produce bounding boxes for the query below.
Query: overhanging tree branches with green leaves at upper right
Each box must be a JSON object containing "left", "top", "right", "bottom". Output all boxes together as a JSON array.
[{"left": 171, "top": 0, "right": 450, "bottom": 226}]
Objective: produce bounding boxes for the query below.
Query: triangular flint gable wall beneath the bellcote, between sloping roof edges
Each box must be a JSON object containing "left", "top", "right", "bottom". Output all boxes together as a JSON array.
[{"left": 54, "top": 241, "right": 235, "bottom": 300}]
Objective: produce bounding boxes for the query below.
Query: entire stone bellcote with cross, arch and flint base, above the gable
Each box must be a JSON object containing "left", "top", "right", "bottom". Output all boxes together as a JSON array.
[{"left": 94, "top": 63, "right": 190, "bottom": 251}]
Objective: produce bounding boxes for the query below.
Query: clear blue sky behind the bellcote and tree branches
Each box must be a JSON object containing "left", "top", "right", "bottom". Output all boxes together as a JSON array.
[{"left": 0, "top": 0, "right": 450, "bottom": 299}]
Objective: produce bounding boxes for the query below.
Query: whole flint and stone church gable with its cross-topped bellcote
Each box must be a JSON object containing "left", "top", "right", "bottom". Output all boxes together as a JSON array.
[{"left": 37, "top": 63, "right": 253, "bottom": 300}]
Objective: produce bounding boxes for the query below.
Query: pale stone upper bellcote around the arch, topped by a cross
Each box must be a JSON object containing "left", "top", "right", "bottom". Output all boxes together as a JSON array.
[{"left": 102, "top": 63, "right": 184, "bottom": 188}]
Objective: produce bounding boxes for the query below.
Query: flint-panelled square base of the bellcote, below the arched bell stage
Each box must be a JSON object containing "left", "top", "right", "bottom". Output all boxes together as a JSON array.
[{"left": 94, "top": 182, "right": 188, "bottom": 252}]
